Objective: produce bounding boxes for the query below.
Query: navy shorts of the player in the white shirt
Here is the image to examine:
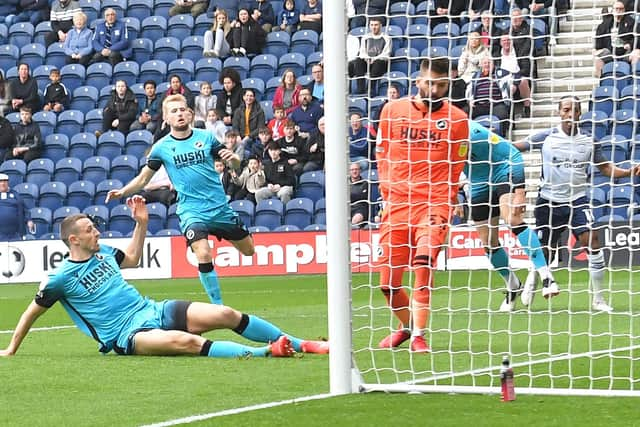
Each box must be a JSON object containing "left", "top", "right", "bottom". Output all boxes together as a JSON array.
[{"left": 534, "top": 196, "right": 594, "bottom": 248}]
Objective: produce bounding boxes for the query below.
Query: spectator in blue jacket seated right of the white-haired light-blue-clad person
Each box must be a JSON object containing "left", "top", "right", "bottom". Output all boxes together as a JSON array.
[{"left": 91, "top": 8, "right": 129, "bottom": 65}]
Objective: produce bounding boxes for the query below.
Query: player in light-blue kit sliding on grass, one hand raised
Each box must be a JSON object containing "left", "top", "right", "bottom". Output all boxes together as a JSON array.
[{"left": 0, "top": 196, "right": 329, "bottom": 357}]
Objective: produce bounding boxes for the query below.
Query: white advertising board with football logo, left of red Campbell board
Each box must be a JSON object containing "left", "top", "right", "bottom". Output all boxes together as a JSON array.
[{"left": 0, "top": 237, "right": 171, "bottom": 283}]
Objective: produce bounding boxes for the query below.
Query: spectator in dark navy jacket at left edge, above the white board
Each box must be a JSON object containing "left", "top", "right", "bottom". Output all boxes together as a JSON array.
[{"left": 0, "top": 173, "right": 35, "bottom": 242}]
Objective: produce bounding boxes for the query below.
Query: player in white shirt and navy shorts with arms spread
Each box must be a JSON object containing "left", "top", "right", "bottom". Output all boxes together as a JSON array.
[{"left": 516, "top": 96, "right": 640, "bottom": 312}]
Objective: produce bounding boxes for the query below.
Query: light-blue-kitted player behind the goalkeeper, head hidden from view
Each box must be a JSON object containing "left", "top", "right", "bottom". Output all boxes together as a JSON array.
[{"left": 465, "top": 121, "right": 560, "bottom": 312}]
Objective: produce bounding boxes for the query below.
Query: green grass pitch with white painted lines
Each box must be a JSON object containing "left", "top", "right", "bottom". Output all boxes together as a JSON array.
[{"left": 0, "top": 271, "right": 640, "bottom": 426}]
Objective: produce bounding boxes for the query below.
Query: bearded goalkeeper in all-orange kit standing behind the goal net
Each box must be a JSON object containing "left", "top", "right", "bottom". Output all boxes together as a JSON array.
[{"left": 376, "top": 58, "right": 469, "bottom": 353}]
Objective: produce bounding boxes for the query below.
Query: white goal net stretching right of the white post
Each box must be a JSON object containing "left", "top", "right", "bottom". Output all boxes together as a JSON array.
[{"left": 336, "top": 0, "right": 640, "bottom": 395}]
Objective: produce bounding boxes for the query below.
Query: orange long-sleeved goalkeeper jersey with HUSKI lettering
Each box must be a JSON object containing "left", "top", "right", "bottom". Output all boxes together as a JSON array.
[{"left": 376, "top": 98, "right": 469, "bottom": 210}]
